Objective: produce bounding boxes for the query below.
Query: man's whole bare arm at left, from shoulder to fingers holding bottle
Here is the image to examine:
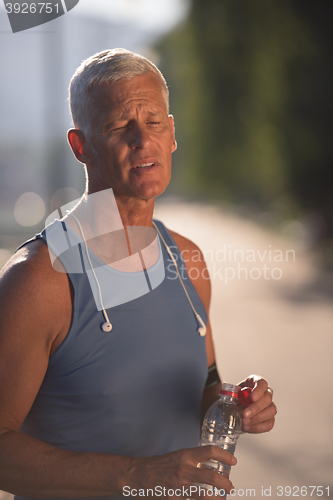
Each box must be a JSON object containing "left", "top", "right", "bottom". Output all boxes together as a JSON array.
[{"left": 0, "top": 241, "right": 235, "bottom": 498}]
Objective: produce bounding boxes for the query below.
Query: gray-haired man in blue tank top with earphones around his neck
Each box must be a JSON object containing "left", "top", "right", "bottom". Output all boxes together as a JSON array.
[{"left": 0, "top": 49, "right": 276, "bottom": 498}]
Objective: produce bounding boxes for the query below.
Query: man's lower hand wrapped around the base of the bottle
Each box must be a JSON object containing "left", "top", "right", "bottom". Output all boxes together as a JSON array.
[{"left": 125, "top": 445, "right": 237, "bottom": 500}]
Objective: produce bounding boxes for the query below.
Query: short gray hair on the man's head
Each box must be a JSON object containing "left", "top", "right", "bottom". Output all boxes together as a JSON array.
[{"left": 69, "top": 49, "right": 169, "bottom": 132}]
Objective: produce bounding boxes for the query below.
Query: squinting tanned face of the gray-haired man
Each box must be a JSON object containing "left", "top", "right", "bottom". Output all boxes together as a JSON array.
[{"left": 87, "top": 72, "right": 176, "bottom": 200}]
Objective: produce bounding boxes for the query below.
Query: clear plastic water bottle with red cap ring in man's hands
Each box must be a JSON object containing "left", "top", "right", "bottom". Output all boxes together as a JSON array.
[{"left": 200, "top": 383, "right": 242, "bottom": 498}]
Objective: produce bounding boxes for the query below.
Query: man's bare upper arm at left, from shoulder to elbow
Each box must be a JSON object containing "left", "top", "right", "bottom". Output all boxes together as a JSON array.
[{"left": 0, "top": 240, "right": 71, "bottom": 434}]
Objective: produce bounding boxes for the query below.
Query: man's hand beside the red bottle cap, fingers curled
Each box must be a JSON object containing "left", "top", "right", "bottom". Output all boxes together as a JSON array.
[{"left": 238, "top": 375, "right": 277, "bottom": 433}]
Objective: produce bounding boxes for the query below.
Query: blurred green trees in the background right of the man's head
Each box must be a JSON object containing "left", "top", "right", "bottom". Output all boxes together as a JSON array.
[{"left": 159, "top": 0, "right": 333, "bottom": 240}]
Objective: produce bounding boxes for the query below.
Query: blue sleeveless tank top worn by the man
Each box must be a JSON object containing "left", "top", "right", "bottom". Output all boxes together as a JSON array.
[{"left": 17, "top": 221, "right": 207, "bottom": 498}]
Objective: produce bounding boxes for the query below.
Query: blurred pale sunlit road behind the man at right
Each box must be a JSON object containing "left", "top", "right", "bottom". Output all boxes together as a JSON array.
[{"left": 0, "top": 201, "right": 333, "bottom": 500}]
